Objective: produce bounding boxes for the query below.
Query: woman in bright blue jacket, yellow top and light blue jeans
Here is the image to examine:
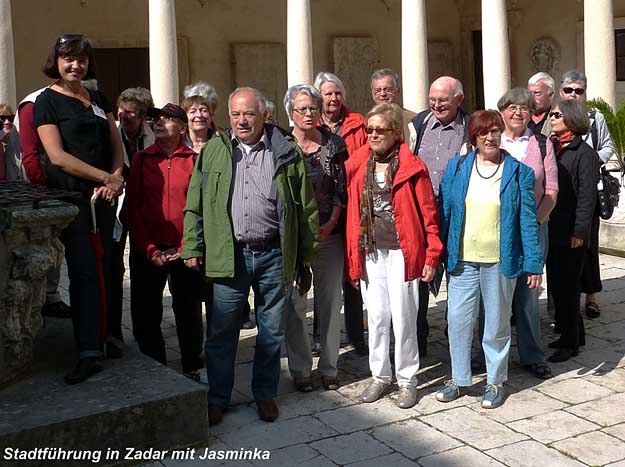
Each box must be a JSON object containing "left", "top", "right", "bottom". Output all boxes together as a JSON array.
[{"left": 436, "top": 110, "right": 543, "bottom": 408}]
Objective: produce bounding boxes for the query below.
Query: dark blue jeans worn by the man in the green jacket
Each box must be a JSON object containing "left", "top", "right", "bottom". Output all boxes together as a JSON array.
[{"left": 204, "top": 246, "right": 290, "bottom": 406}]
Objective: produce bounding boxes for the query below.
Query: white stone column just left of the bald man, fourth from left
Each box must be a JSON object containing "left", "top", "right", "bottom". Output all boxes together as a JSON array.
[{"left": 401, "top": 0, "right": 429, "bottom": 112}]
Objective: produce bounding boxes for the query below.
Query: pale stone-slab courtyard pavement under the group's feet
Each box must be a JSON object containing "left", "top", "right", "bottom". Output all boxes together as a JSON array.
[{"left": 101, "top": 255, "right": 625, "bottom": 467}]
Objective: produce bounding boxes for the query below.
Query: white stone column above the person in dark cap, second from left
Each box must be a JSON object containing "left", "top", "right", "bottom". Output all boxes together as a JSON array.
[{"left": 149, "top": 0, "right": 179, "bottom": 107}]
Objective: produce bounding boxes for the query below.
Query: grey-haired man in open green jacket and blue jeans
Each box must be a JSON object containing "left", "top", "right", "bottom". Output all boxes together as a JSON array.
[{"left": 182, "top": 88, "right": 319, "bottom": 425}]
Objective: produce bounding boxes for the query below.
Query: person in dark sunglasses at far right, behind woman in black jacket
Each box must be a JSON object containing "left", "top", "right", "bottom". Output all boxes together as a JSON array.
[{"left": 560, "top": 70, "right": 614, "bottom": 319}]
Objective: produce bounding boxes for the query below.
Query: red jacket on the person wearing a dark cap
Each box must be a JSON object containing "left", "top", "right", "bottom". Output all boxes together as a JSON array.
[{"left": 126, "top": 140, "right": 196, "bottom": 259}]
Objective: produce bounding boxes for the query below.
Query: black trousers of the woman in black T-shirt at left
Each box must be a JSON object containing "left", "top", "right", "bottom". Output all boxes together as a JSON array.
[{"left": 60, "top": 199, "right": 115, "bottom": 358}]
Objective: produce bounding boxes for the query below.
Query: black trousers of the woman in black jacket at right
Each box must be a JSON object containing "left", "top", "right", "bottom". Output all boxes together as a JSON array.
[{"left": 547, "top": 238, "right": 587, "bottom": 350}]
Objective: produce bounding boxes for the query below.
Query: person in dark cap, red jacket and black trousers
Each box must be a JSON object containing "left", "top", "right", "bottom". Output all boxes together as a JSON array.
[{"left": 126, "top": 104, "right": 204, "bottom": 381}]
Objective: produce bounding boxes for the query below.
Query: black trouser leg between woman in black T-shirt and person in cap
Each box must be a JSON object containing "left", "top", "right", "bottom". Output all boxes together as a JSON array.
[{"left": 107, "top": 226, "right": 128, "bottom": 341}]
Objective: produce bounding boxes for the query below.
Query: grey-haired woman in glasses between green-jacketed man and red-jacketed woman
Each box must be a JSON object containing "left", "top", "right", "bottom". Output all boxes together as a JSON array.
[{"left": 284, "top": 84, "right": 347, "bottom": 392}]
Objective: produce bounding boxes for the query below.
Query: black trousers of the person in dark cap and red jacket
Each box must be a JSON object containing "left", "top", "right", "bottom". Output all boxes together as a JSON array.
[{"left": 130, "top": 247, "right": 206, "bottom": 373}]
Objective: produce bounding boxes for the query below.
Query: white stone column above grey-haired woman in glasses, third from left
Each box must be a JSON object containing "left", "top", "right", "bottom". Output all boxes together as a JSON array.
[{"left": 286, "top": 0, "right": 314, "bottom": 87}]
